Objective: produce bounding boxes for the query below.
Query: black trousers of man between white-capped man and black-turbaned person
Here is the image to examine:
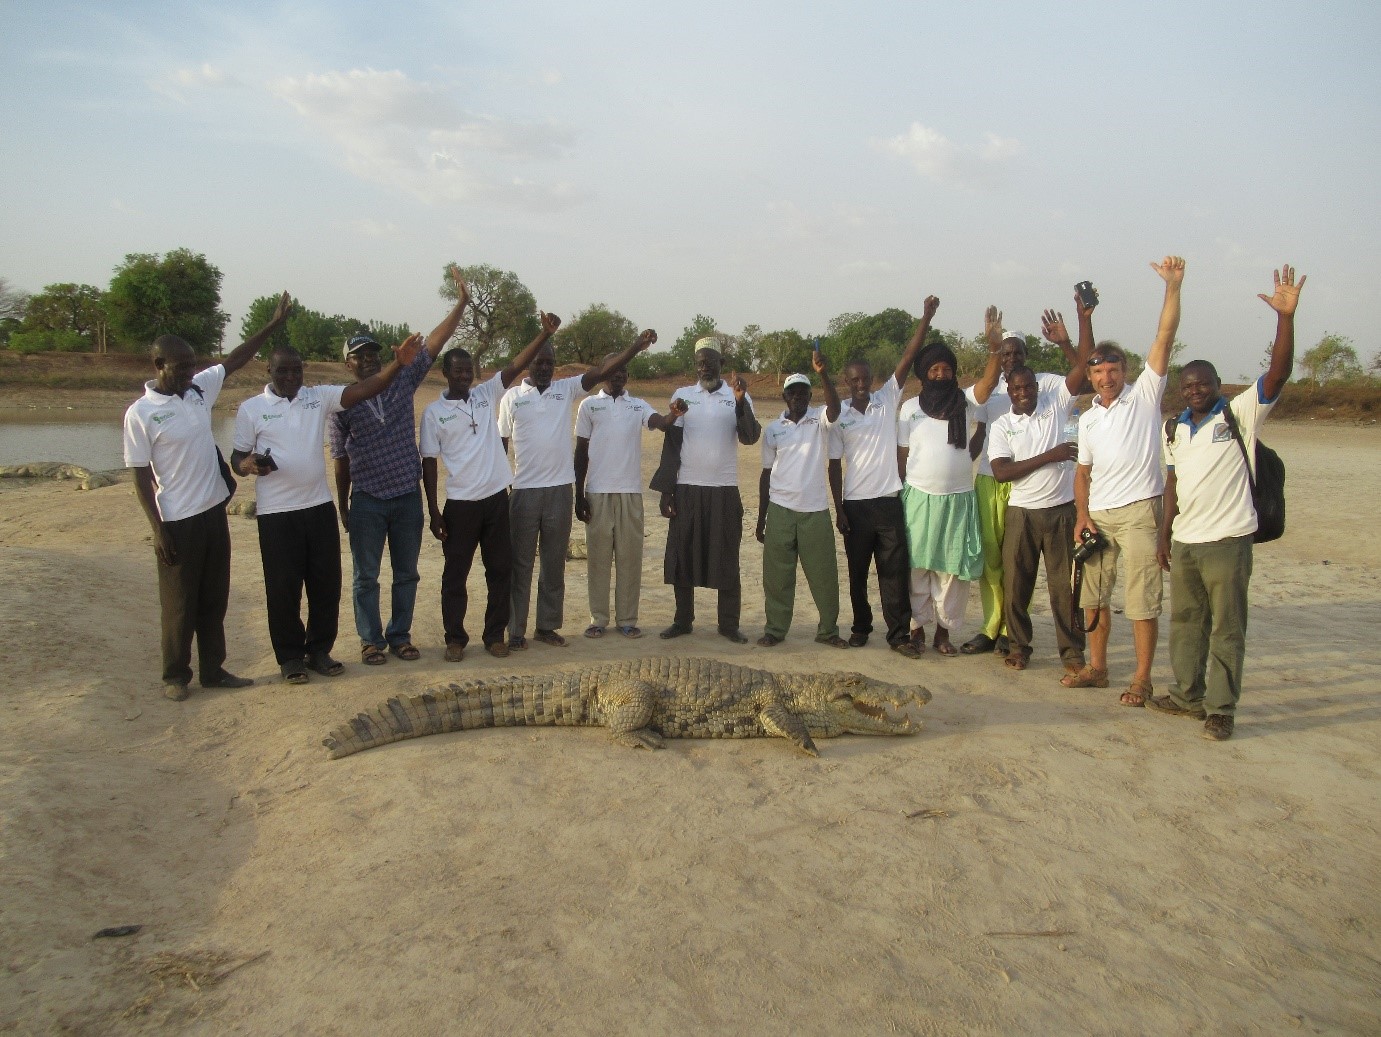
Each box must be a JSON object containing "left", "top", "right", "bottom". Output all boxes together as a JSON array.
[{"left": 844, "top": 497, "right": 911, "bottom": 645}]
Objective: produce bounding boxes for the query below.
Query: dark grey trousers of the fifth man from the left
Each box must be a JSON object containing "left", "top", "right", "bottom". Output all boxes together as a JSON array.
[{"left": 508, "top": 482, "right": 574, "bottom": 639}]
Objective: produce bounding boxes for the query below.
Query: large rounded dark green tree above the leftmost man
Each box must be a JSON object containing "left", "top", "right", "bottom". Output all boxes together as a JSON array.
[{"left": 106, "top": 249, "right": 231, "bottom": 355}]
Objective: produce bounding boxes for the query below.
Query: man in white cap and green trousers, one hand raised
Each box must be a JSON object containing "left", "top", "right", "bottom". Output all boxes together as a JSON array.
[{"left": 757, "top": 356, "right": 849, "bottom": 648}]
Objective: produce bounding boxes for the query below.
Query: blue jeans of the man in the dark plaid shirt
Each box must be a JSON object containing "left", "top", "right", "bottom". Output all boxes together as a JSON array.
[{"left": 349, "top": 489, "right": 423, "bottom": 648}]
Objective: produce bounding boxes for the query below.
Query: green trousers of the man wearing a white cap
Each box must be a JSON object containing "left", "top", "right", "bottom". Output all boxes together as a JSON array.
[{"left": 762, "top": 504, "right": 840, "bottom": 638}]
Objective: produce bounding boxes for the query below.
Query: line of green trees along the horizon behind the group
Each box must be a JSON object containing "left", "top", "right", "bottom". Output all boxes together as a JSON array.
[{"left": 0, "top": 255, "right": 1381, "bottom": 384}]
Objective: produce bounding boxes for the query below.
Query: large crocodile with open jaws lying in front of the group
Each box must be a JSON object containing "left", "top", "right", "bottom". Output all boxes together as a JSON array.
[{"left": 322, "top": 656, "right": 931, "bottom": 759}]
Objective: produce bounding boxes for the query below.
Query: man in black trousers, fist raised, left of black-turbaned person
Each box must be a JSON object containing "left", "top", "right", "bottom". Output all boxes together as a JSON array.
[{"left": 830, "top": 295, "right": 940, "bottom": 659}]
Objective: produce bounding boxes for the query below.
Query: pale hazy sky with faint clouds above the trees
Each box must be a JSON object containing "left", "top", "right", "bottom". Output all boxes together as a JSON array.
[{"left": 0, "top": 0, "right": 1381, "bottom": 380}]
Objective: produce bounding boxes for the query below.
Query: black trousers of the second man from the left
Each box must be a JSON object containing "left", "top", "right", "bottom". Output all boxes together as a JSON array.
[{"left": 258, "top": 501, "right": 341, "bottom": 666}]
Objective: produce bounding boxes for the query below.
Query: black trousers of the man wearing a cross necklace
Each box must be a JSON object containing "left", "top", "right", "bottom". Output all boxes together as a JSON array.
[{"left": 441, "top": 490, "right": 514, "bottom": 648}]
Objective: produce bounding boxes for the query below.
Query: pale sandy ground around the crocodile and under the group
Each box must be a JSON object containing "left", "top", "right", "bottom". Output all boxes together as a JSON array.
[{"left": 0, "top": 408, "right": 1381, "bottom": 1034}]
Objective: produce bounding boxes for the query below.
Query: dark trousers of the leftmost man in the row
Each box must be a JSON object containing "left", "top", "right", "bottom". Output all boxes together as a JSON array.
[{"left": 157, "top": 504, "right": 231, "bottom": 684}]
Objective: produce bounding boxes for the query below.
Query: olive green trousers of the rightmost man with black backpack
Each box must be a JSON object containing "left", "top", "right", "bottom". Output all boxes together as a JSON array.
[{"left": 1170, "top": 536, "right": 1251, "bottom": 717}]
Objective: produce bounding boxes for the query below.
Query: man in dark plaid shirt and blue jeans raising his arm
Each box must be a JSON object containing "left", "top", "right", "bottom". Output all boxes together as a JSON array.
[{"left": 327, "top": 264, "right": 470, "bottom": 666}]
